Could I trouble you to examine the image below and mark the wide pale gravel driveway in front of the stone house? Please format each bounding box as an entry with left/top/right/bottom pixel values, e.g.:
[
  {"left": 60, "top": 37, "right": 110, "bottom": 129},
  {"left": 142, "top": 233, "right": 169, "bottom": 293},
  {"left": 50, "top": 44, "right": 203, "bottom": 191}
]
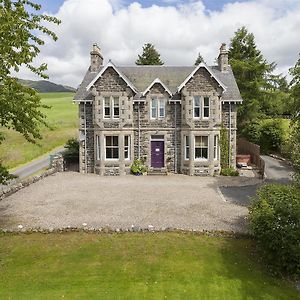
[{"left": 0, "top": 172, "right": 248, "bottom": 232}]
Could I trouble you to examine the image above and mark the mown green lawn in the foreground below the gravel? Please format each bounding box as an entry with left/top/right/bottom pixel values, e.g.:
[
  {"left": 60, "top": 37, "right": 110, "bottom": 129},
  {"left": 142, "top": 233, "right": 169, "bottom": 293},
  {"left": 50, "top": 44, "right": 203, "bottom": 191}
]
[{"left": 0, "top": 233, "right": 300, "bottom": 300}]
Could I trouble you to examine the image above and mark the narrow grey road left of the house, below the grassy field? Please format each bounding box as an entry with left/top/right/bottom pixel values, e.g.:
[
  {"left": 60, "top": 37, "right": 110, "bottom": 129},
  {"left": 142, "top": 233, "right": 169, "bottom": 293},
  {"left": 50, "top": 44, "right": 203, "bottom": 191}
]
[{"left": 12, "top": 147, "right": 64, "bottom": 179}]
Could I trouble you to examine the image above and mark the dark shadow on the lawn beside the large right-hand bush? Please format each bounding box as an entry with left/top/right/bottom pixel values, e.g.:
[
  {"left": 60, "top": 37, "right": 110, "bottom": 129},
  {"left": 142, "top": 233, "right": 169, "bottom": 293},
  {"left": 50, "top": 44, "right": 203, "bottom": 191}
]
[{"left": 216, "top": 238, "right": 300, "bottom": 300}]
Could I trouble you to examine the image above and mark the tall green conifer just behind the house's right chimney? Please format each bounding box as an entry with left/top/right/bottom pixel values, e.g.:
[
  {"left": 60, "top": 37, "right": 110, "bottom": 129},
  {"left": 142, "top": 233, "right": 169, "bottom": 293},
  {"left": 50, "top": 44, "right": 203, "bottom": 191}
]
[{"left": 229, "top": 27, "right": 276, "bottom": 127}]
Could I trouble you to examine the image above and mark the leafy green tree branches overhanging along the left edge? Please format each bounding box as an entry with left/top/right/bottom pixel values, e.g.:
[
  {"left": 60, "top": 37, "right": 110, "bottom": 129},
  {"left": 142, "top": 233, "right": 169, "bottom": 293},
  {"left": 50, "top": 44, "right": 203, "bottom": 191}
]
[{"left": 0, "top": 0, "right": 60, "bottom": 183}]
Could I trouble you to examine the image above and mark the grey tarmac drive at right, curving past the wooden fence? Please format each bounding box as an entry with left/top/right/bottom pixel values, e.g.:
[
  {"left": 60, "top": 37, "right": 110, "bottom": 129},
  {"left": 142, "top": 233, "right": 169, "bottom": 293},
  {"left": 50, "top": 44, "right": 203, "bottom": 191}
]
[{"left": 219, "top": 155, "right": 293, "bottom": 206}]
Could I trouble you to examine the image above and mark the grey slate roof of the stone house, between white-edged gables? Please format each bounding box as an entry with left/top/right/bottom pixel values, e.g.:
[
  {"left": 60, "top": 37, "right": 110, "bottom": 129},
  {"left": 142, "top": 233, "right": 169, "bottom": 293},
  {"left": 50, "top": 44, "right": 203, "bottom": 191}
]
[{"left": 74, "top": 66, "right": 242, "bottom": 101}]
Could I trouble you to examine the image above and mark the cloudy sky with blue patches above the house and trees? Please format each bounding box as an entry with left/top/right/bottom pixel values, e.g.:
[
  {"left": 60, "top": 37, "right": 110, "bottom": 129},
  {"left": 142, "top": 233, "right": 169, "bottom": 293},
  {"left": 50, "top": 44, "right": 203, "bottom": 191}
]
[{"left": 18, "top": 0, "right": 300, "bottom": 87}]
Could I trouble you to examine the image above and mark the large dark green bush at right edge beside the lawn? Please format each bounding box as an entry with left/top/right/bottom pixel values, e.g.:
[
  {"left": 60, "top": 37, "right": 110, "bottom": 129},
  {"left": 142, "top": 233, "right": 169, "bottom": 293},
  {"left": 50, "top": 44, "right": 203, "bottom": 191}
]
[{"left": 250, "top": 184, "right": 300, "bottom": 275}]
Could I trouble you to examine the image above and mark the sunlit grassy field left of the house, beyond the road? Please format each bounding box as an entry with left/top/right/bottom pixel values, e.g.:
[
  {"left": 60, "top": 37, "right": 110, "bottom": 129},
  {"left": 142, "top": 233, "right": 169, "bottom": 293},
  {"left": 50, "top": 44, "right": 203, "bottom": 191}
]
[{"left": 0, "top": 93, "right": 78, "bottom": 168}]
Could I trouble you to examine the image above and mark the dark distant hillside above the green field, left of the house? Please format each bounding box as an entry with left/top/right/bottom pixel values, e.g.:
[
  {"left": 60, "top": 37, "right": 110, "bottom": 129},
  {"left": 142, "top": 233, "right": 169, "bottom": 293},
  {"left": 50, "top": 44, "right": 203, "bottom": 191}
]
[{"left": 19, "top": 79, "right": 75, "bottom": 93}]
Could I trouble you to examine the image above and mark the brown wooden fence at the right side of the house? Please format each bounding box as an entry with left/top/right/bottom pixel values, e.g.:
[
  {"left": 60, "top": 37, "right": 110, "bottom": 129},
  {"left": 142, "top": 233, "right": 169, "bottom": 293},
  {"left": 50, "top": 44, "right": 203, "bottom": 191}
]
[{"left": 237, "top": 138, "right": 265, "bottom": 178}]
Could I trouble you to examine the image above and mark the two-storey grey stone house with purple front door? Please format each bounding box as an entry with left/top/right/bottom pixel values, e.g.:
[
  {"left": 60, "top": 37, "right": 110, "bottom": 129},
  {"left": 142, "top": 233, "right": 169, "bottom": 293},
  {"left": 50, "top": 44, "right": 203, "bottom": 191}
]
[{"left": 74, "top": 44, "right": 242, "bottom": 175}]
